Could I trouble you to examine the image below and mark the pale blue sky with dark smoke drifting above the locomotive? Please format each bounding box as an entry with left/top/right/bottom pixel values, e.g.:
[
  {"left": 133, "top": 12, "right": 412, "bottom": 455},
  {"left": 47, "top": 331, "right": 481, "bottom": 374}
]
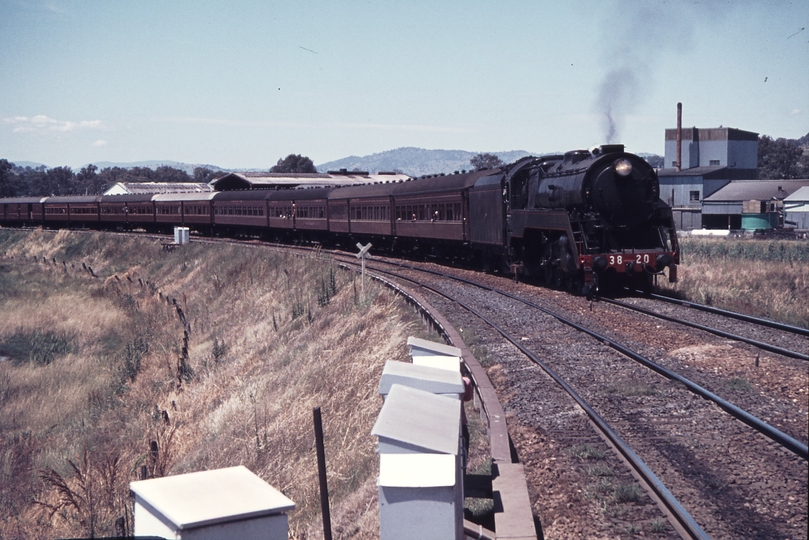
[{"left": 0, "top": 0, "right": 809, "bottom": 169}]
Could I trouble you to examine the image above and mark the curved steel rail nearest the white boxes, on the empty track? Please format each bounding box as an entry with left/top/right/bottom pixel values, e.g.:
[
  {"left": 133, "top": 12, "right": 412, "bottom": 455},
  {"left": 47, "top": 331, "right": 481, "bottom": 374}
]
[{"left": 362, "top": 269, "right": 710, "bottom": 539}]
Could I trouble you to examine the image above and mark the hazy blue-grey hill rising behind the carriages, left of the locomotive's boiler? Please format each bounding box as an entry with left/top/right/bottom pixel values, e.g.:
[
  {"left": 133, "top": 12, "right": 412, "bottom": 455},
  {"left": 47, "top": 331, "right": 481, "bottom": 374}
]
[{"left": 317, "top": 147, "right": 540, "bottom": 176}]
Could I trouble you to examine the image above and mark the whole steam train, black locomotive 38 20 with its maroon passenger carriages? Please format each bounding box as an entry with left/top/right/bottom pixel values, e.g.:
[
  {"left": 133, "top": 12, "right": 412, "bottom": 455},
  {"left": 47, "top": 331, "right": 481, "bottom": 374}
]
[{"left": 0, "top": 145, "right": 679, "bottom": 295}]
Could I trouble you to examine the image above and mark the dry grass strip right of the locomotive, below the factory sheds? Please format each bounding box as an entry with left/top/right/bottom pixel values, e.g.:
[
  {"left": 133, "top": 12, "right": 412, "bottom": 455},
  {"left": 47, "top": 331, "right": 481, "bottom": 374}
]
[{"left": 658, "top": 238, "right": 809, "bottom": 328}]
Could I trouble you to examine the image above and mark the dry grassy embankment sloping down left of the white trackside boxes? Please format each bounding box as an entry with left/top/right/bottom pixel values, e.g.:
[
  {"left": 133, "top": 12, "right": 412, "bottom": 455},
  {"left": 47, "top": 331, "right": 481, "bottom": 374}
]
[{"left": 0, "top": 230, "right": 437, "bottom": 538}]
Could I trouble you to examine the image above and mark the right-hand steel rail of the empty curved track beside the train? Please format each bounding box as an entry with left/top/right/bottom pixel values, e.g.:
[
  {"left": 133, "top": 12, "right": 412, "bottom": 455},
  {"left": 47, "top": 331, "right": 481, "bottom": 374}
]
[{"left": 368, "top": 263, "right": 809, "bottom": 461}]
